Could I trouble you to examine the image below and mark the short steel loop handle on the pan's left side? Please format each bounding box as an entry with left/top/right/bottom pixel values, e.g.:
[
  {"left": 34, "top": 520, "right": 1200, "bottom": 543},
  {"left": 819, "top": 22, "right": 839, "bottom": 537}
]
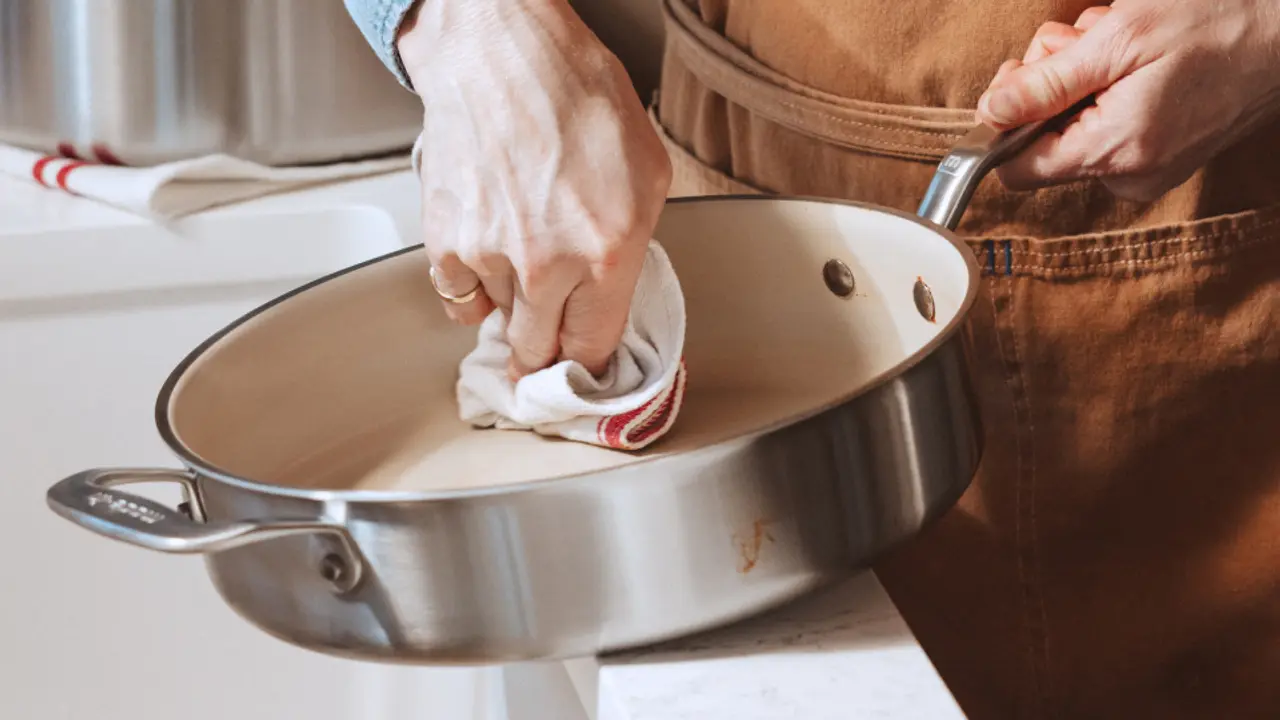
[{"left": 46, "top": 468, "right": 361, "bottom": 589}]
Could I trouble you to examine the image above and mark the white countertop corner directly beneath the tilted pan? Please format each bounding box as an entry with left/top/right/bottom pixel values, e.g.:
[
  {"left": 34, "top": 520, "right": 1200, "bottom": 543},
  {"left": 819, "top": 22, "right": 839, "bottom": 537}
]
[{"left": 568, "top": 573, "right": 964, "bottom": 720}]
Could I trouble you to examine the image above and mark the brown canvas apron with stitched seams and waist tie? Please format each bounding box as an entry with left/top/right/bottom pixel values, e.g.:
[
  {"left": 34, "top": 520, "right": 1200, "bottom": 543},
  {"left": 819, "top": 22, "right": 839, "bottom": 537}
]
[{"left": 654, "top": 0, "right": 1280, "bottom": 720}]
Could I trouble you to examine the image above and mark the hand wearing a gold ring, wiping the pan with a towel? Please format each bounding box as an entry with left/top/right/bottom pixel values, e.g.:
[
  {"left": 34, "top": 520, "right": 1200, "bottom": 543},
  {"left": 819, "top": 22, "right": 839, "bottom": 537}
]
[{"left": 397, "top": 0, "right": 672, "bottom": 378}]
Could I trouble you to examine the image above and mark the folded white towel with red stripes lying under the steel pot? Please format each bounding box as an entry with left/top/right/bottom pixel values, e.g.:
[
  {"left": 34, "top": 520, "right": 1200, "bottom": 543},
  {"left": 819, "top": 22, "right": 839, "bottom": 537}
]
[{"left": 0, "top": 145, "right": 410, "bottom": 219}]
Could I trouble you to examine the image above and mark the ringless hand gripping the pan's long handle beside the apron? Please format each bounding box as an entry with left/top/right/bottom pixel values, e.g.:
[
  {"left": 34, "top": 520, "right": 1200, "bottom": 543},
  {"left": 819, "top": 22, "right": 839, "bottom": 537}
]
[{"left": 978, "top": 0, "right": 1280, "bottom": 200}]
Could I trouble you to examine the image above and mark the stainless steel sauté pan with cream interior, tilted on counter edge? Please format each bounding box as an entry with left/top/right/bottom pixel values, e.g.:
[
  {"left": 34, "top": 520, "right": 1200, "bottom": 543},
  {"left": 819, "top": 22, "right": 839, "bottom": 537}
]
[{"left": 49, "top": 116, "right": 1054, "bottom": 664}]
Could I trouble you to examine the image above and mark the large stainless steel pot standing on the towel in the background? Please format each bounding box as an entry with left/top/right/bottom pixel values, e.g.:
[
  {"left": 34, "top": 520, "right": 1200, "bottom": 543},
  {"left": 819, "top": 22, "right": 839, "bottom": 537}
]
[{"left": 0, "top": 0, "right": 422, "bottom": 165}]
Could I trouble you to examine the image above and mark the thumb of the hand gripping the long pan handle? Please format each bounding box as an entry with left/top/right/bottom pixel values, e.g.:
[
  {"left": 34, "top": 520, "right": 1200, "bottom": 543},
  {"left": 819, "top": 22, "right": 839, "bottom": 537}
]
[{"left": 978, "top": 33, "right": 1114, "bottom": 129}]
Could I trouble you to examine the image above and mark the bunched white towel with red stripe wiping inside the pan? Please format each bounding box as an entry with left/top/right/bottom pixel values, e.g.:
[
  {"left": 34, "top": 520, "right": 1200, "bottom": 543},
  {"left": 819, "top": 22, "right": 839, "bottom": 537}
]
[{"left": 457, "top": 241, "right": 685, "bottom": 450}]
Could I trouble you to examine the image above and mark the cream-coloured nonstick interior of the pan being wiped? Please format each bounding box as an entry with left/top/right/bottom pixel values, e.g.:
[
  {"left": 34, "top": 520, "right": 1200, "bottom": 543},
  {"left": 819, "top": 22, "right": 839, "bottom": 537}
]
[{"left": 166, "top": 197, "right": 974, "bottom": 492}]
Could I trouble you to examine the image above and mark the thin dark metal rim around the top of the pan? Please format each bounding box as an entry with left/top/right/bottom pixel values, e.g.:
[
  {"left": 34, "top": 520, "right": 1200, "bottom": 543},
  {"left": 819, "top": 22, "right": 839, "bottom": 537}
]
[{"left": 155, "top": 193, "right": 980, "bottom": 503}]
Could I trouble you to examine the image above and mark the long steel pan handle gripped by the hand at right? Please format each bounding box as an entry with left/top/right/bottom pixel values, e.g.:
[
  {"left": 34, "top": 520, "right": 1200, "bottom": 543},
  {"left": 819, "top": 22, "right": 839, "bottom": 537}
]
[{"left": 916, "top": 97, "right": 1093, "bottom": 231}]
